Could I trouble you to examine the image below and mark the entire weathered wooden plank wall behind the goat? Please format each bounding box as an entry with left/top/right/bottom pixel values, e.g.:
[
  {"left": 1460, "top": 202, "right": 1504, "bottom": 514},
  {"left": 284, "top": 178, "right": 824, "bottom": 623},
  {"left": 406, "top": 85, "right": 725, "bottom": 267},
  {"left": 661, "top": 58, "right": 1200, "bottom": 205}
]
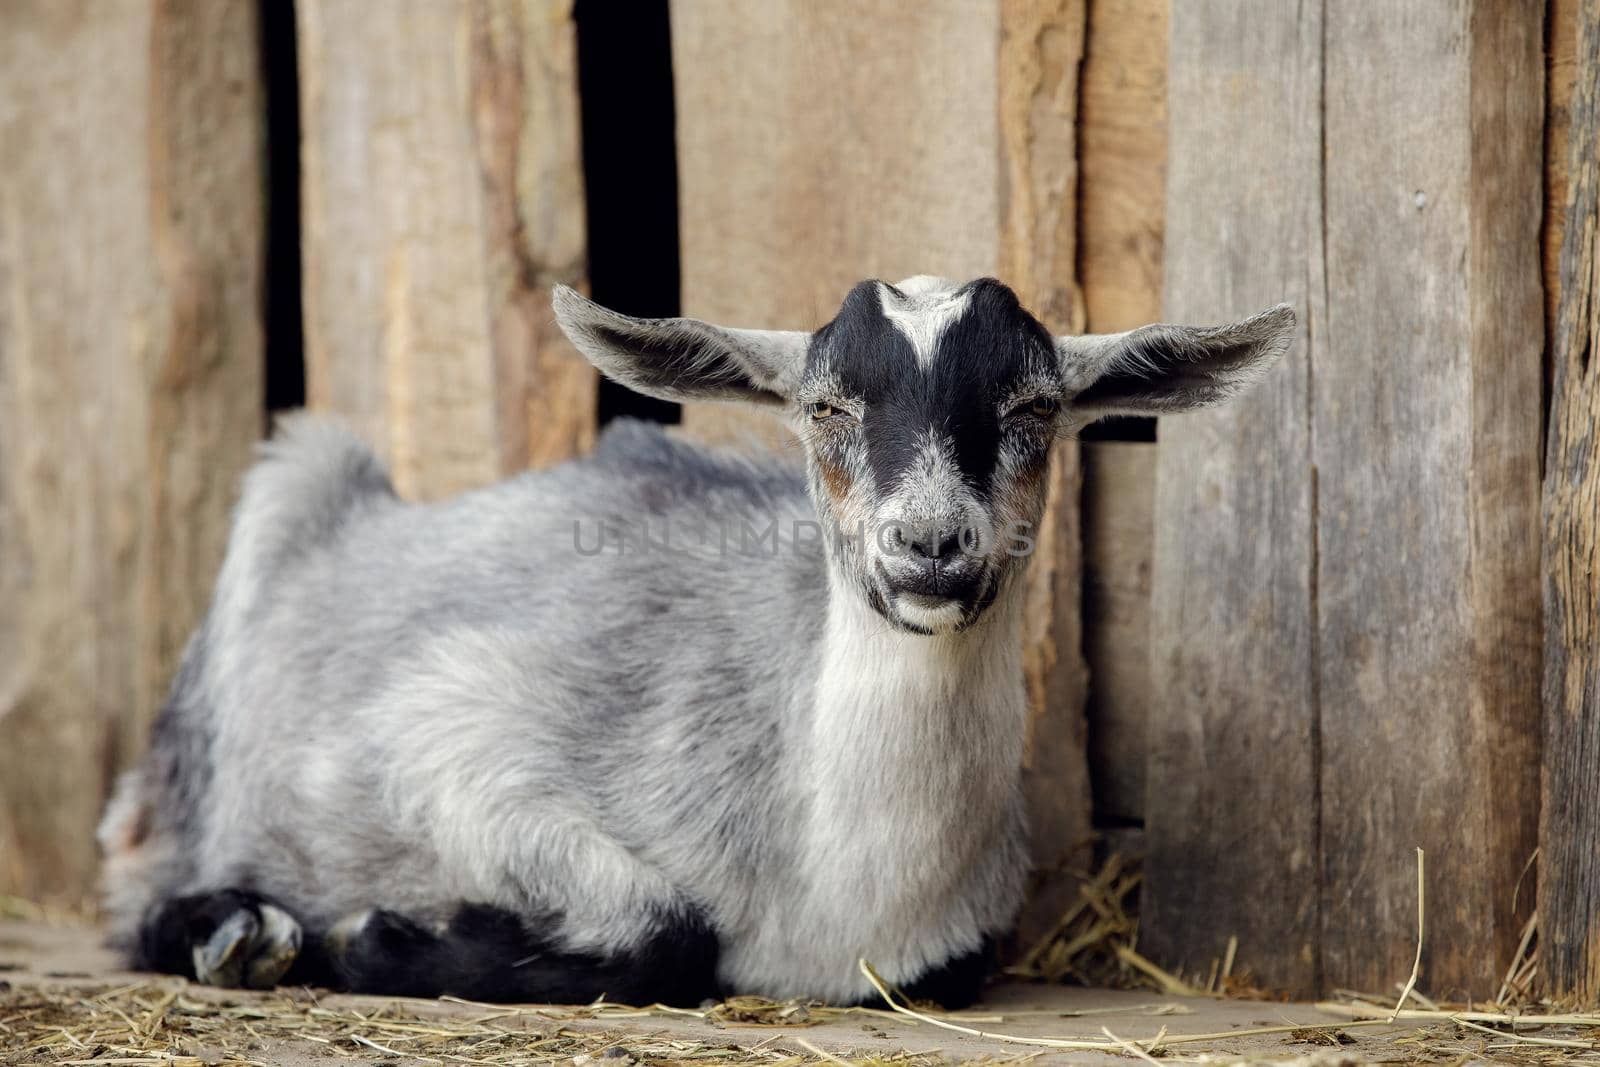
[{"left": 0, "top": 0, "right": 1580, "bottom": 1000}]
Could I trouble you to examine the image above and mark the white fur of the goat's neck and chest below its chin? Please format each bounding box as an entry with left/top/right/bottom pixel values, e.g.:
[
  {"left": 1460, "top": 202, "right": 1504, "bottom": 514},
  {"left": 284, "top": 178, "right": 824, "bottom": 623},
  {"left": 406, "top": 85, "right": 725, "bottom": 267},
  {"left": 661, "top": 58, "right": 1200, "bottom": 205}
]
[{"left": 725, "top": 597, "right": 1026, "bottom": 998}]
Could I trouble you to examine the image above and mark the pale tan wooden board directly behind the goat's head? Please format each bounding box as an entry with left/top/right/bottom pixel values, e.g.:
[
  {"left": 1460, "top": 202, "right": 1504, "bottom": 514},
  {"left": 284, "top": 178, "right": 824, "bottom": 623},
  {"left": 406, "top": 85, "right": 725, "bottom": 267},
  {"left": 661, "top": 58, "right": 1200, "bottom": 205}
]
[{"left": 672, "top": 0, "right": 1090, "bottom": 937}]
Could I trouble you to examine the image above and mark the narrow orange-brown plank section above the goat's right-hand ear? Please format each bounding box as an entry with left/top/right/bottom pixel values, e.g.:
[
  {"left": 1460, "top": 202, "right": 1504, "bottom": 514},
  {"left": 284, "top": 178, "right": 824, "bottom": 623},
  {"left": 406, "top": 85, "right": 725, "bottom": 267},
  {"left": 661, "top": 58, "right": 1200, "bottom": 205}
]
[{"left": 1078, "top": 0, "right": 1171, "bottom": 333}]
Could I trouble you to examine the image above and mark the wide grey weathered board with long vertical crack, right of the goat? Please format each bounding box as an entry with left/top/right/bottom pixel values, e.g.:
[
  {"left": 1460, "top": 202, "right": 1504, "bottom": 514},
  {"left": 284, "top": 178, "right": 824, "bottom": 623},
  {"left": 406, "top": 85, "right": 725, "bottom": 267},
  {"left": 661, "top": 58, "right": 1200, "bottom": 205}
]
[{"left": 1142, "top": 0, "right": 1544, "bottom": 997}]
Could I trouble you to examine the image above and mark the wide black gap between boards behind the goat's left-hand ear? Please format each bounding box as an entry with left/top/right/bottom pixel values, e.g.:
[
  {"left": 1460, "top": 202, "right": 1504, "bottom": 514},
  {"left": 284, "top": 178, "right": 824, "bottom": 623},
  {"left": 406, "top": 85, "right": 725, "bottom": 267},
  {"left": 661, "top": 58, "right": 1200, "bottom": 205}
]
[{"left": 573, "top": 0, "right": 680, "bottom": 426}]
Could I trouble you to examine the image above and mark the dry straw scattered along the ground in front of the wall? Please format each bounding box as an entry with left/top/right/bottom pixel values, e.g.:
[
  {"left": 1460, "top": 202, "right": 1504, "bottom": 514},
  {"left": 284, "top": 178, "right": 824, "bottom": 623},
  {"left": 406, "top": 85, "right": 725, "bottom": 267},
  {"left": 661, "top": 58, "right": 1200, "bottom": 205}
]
[{"left": 0, "top": 854, "right": 1600, "bottom": 1067}]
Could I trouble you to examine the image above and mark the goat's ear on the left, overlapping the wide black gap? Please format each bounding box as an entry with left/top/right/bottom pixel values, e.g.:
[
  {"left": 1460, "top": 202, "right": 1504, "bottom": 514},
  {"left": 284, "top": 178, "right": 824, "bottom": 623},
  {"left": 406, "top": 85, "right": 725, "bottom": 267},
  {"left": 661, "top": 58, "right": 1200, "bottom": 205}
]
[{"left": 550, "top": 285, "right": 811, "bottom": 403}]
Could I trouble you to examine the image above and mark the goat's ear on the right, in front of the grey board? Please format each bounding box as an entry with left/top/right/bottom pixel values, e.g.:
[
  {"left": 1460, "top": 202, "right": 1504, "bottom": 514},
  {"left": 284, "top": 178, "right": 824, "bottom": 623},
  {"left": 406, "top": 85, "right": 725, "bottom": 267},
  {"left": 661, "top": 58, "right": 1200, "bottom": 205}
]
[{"left": 1056, "top": 304, "right": 1294, "bottom": 422}]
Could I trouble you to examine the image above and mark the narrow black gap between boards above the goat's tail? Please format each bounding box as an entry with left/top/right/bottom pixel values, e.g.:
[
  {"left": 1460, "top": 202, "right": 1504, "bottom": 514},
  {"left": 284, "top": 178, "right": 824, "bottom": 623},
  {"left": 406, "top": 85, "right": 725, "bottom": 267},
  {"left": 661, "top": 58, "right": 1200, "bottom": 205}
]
[{"left": 256, "top": 0, "right": 306, "bottom": 413}]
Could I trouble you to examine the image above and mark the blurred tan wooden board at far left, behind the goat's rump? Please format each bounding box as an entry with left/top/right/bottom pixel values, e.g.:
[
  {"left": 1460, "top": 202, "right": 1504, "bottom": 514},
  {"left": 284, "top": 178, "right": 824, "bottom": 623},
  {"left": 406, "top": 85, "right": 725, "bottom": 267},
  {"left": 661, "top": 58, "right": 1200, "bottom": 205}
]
[{"left": 0, "top": 0, "right": 262, "bottom": 902}]
